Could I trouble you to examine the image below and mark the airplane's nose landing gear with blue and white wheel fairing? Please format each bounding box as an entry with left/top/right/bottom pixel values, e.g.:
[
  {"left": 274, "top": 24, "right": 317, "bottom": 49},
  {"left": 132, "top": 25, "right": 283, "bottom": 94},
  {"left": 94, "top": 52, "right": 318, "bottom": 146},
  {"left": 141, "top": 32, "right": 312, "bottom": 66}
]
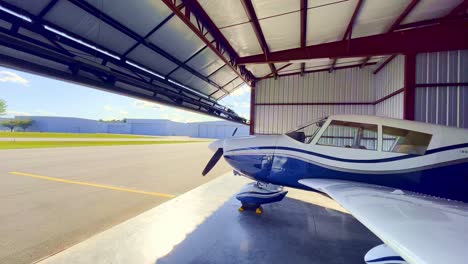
[{"left": 236, "top": 182, "right": 288, "bottom": 215}]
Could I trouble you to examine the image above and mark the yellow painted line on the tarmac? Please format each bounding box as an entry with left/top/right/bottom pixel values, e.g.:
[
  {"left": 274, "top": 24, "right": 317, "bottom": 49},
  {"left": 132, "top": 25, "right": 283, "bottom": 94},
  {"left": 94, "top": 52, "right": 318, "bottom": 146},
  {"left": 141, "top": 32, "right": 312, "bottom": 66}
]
[{"left": 10, "top": 171, "right": 175, "bottom": 198}]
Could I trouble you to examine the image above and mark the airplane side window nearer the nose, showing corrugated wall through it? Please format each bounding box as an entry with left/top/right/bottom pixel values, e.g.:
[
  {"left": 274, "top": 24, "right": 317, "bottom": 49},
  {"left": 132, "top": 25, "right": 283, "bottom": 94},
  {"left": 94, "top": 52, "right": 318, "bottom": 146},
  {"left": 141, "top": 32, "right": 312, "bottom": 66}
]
[{"left": 317, "top": 120, "right": 377, "bottom": 150}]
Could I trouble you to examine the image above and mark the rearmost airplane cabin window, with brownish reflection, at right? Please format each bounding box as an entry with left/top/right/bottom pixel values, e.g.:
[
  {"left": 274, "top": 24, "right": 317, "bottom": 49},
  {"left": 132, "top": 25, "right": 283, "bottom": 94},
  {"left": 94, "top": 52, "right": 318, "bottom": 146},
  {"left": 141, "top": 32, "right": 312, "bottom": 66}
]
[{"left": 382, "top": 126, "right": 432, "bottom": 155}]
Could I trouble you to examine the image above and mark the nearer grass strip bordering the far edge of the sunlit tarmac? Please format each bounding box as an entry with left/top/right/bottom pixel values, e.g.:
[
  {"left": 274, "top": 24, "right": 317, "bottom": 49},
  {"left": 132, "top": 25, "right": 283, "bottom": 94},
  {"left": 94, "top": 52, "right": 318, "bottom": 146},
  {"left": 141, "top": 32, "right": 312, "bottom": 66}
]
[{"left": 0, "top": 140, "right": 200, "bottom": 149}]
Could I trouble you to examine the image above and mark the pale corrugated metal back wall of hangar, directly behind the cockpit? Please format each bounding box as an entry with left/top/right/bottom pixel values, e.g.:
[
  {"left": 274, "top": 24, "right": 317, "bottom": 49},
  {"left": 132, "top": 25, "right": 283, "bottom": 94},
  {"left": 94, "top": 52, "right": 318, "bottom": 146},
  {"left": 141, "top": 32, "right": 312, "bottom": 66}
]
[{"left": 255, "top": 68, "right": 375, "bottom": 134}]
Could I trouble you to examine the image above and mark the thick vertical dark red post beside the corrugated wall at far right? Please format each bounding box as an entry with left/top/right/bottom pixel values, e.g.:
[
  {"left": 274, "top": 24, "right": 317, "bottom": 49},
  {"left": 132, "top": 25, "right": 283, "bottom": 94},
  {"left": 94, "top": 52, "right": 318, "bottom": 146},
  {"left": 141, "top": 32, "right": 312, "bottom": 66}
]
[{"left": 403, "top": 53, "right": 416, "bottom": 120}]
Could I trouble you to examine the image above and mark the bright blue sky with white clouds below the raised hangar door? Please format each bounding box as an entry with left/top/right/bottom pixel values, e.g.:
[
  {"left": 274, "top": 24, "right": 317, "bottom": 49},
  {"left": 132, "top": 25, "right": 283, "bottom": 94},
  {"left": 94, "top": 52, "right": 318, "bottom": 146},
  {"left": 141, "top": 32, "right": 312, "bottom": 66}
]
[{"left": 0, "top": 67, "right": 250, "bottom": 122}]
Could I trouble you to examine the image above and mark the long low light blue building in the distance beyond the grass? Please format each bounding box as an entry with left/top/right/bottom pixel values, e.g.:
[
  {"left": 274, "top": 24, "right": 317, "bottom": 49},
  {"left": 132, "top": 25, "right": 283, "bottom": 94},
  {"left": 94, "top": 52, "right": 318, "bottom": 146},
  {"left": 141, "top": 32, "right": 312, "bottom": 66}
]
[{"left": 0, "top": 116, "right": 249, "bottom": 138}]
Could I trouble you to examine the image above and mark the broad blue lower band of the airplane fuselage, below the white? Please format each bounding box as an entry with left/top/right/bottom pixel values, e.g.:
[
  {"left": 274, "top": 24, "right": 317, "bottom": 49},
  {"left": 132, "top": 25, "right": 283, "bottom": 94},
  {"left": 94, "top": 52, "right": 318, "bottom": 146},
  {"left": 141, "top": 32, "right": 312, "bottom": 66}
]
[{"left": 225, "top": 154, "right": 468, "bottom": 202}]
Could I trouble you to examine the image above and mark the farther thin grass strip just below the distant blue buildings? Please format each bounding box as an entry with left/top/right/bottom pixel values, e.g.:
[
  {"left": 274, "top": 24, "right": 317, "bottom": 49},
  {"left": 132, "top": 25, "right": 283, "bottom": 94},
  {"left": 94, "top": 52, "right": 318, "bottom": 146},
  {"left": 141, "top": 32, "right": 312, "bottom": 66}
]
[{"left": 0, "top": 132, "right": 155, "bottom": 138}]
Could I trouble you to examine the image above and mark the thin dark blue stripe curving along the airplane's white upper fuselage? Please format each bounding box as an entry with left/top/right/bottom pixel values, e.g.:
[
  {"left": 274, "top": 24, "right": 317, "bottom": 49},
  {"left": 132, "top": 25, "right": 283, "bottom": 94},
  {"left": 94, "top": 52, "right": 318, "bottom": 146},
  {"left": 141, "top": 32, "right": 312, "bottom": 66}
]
[{"left": 226, "top": 143, "right": 468, "bottom": 163}]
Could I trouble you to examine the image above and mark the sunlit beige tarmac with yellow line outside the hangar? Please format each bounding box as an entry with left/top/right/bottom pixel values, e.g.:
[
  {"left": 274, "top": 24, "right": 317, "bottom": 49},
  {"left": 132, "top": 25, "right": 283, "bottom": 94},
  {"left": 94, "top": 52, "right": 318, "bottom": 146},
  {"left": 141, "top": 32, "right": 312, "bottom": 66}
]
[{"left": 0, "top": 142, "right": 230, "bottom": 263}]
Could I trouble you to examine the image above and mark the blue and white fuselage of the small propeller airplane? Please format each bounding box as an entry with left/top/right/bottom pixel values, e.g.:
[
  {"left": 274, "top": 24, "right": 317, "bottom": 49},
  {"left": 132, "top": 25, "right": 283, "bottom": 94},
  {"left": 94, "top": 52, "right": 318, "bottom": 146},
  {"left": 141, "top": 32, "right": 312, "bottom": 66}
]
[{"left": 218, "top": 115, "right": 468, "bottom": 202}]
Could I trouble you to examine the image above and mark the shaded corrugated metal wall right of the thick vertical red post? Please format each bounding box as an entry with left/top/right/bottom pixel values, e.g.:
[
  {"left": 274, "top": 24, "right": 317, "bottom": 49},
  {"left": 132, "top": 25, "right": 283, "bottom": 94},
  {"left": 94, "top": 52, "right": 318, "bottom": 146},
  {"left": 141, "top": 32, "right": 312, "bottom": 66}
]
[{"left": 415, "top": 50, "right": 468, "bottom": 128}]
